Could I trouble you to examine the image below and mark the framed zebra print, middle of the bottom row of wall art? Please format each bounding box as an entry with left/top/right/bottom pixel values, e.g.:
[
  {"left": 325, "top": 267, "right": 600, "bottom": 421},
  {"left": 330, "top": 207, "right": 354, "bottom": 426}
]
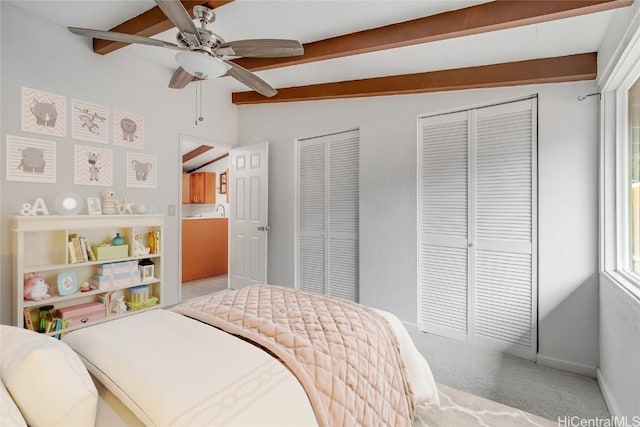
[{"left": 73, "top": 145, "right": 113, "bottom": 187}]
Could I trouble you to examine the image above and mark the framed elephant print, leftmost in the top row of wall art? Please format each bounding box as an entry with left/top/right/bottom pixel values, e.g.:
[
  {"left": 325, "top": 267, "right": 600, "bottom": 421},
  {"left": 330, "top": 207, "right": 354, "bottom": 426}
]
[{"left": 20, "top": 87, "right": 67, "bottom": 137}]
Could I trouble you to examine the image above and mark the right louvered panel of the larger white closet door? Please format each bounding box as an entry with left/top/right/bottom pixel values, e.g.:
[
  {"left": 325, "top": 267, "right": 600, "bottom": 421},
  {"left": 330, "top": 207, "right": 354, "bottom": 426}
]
[{"left": 471, "top": 99, "right": 537, "bottom": 358}]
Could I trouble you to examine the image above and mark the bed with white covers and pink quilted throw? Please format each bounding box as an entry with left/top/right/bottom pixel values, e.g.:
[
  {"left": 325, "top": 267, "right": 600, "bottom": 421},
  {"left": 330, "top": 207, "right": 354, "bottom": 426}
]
[{"left": 3, "top": 285, "right": 438, "bottom": 426}]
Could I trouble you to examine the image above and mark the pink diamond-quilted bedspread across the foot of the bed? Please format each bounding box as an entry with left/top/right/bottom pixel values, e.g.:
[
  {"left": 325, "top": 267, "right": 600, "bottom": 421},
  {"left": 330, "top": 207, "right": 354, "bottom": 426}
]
[{"left": 173, "top": 285, "right": 415, "bottom": 426}]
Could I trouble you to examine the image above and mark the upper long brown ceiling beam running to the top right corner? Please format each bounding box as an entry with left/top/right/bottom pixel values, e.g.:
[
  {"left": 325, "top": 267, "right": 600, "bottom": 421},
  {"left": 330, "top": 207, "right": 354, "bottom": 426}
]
[{"left": 234, "top": 0, "right": 633, "bottom": 71}]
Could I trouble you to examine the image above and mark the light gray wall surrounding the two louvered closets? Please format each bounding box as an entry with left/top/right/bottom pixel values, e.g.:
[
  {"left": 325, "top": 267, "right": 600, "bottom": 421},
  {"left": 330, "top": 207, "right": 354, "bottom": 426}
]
[{"left": 238, "top": 82, "right": 598, "bottom": 372}]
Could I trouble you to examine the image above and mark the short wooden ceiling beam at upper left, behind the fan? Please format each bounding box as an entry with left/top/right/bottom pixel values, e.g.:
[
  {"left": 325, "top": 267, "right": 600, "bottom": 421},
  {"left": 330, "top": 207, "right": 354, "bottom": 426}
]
[{"left": 93, "top": 0, "right": 233, "bottom": 55}]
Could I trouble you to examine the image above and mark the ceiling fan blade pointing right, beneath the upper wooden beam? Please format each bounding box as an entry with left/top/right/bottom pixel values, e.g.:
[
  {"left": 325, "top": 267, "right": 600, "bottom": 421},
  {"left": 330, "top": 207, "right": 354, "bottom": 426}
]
[{"left": 216, "top": 39, "right": 304, "bottom": 58}]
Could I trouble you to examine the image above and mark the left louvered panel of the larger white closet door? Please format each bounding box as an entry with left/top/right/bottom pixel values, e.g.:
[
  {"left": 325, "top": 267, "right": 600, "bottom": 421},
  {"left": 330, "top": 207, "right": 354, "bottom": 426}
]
[{"left": 418, "top": 112, "right": 469, "bottom": 339}]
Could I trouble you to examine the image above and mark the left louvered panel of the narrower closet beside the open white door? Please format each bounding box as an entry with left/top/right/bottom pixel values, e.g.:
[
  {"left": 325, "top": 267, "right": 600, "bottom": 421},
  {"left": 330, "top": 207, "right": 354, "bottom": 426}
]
[{"left": 296, "top": 137, "right": 327, "bottom": 295}]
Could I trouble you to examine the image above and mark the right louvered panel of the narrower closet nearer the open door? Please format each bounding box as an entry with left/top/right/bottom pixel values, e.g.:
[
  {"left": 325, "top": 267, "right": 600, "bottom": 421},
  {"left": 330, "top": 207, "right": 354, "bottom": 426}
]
[{"left": 328, "top": 131, "right": 360, "bottom": 302}]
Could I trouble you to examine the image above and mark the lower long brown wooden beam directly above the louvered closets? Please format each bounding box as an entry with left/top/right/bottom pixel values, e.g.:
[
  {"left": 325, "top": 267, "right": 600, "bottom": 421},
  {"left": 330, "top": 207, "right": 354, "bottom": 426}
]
[{"left": 231, "top": 53, "right": 598, "bottom": 105}]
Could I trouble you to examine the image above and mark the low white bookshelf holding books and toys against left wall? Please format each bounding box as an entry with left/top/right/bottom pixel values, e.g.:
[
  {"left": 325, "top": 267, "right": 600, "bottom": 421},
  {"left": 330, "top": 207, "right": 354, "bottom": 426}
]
[{"left": 9, "top": 215, "right": 165, "bottom": 335}]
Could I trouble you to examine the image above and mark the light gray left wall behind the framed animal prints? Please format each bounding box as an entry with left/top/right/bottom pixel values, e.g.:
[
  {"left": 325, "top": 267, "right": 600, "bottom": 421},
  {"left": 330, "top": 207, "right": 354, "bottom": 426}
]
[{"left": 0, "top": 2, "right": 237, "bottom": 323}]
